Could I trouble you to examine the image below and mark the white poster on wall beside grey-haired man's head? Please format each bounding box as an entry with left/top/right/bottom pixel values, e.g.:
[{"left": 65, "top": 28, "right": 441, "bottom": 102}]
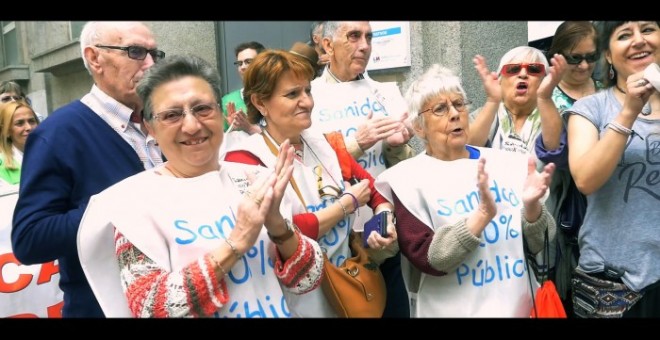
[{"left": 367, "top": 21, "right": 410, "bottom": 70}]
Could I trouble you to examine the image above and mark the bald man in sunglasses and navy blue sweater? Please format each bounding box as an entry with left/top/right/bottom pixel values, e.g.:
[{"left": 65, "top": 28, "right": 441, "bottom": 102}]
[{"left": 11, "top": 21, "right": 165, "bottom": 317}]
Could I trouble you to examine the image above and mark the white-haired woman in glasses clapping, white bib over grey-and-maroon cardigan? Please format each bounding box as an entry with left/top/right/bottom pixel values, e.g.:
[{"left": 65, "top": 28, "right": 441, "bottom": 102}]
[{"left": 376, "top": 65, "right": 555, "bottom": 317}]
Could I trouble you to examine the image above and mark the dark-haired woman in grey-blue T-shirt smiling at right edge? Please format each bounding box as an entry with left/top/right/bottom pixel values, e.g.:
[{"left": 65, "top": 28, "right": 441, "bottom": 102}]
[{"left": 567, "top": 21, "right": 660, "bottom": 318}]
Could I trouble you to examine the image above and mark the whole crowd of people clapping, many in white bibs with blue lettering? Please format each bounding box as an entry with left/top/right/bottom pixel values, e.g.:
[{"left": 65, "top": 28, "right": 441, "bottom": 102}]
[{"left": 0, "top": 21, "right": 660, "bottom": 318}]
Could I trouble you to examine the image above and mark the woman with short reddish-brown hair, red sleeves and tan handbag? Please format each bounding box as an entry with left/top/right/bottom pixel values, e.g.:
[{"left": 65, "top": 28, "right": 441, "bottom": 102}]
[{"left": 225, "top": 50, "right": 398, "bottom": 317}]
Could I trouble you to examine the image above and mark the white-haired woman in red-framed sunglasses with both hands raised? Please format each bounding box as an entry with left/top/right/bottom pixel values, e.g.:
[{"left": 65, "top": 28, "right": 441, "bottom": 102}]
[{"left": 468, "top": 46, "right": 566, "bottom": 162}]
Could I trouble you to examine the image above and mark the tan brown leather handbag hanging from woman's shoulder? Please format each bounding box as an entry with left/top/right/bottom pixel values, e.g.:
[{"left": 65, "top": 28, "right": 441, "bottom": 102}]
[{"left": 321, "top": 232, "right": 387, "bottom": 318}]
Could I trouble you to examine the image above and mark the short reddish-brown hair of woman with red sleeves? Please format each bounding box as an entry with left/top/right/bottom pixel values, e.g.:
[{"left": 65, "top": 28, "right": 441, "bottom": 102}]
[{"left": 243, "top": 49, "right": 314, "bottom": 124}]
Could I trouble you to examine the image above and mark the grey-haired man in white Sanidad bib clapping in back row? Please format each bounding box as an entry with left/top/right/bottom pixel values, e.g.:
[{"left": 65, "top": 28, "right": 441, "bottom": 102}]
[{"left": 312, "top": 21, "right": 414, "bottom": 317}]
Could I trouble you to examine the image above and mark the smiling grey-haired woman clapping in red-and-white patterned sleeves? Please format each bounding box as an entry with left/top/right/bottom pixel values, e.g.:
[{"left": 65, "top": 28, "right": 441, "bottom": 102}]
[{"left": 78, "top": 56, "right": 323, "bottom": 317}]
